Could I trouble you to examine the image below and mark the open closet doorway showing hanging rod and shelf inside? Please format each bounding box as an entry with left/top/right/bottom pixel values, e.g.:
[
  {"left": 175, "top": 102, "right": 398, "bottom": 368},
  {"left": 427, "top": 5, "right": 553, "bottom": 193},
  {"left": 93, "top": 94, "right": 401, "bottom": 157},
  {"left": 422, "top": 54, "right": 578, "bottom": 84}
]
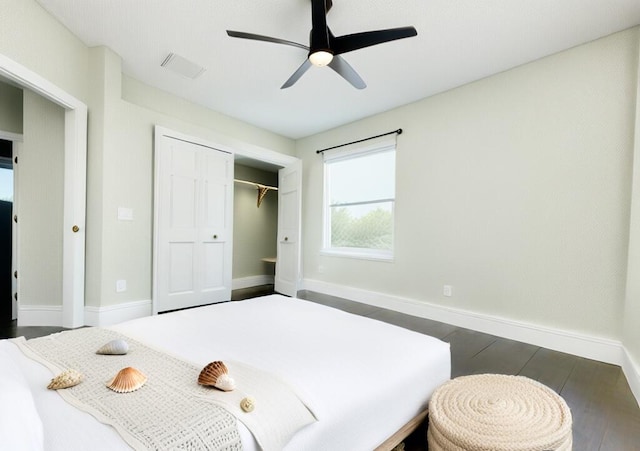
[{"left": 231, "top": 155, "right": 281, "bottom": 300}]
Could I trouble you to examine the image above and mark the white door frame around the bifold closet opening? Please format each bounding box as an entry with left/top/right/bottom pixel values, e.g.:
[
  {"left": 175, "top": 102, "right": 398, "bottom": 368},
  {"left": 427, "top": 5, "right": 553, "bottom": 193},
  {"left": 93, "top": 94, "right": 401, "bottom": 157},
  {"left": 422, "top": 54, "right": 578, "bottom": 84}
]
[{"left": 151, "top": 125, "right": 302, "bottom": 315}]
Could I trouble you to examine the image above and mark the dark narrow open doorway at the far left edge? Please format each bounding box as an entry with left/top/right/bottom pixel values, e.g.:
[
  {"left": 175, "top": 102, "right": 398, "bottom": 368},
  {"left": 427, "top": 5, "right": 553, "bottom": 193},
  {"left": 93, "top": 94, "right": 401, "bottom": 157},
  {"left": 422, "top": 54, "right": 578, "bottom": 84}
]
[{"left": 0, "top": 139, "right": 15, "bottom": 324}]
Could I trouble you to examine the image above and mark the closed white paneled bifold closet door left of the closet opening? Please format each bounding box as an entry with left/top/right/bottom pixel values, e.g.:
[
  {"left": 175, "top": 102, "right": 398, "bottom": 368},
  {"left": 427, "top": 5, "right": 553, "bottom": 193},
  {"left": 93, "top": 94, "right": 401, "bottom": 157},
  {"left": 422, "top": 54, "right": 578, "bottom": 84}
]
[{"left": 154, "top": 136, "right": 234, "bottom": 312}]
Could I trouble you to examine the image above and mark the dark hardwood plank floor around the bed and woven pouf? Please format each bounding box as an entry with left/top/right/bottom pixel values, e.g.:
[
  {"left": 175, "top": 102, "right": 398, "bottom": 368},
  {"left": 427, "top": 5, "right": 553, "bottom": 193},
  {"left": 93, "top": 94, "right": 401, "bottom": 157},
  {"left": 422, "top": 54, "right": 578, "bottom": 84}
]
[{"left": 0, "top": 285, "right": 640, "bottom": 451}]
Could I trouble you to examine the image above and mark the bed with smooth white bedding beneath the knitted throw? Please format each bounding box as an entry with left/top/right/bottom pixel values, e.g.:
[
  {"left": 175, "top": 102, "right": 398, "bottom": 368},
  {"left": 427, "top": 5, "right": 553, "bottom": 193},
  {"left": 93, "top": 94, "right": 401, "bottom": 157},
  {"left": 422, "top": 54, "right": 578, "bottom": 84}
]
[{"left": 0, "top": 295, "right": 451, "bottom": 451}]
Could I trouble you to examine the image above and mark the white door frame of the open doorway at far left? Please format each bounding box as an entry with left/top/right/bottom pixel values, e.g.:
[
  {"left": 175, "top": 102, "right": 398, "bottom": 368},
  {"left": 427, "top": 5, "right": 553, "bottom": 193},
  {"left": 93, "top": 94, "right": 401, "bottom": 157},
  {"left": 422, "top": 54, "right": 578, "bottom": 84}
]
[{"left": 0, "top": 54, "right": 87, "bottom": 328}]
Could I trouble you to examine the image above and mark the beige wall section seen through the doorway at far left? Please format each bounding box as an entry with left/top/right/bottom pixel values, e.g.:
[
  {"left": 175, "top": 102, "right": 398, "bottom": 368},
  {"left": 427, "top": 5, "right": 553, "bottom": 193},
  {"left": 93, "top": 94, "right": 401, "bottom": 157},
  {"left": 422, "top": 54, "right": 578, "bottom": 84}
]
[{"left": 17, "top": 91, "right": 64, "bottom": 307}]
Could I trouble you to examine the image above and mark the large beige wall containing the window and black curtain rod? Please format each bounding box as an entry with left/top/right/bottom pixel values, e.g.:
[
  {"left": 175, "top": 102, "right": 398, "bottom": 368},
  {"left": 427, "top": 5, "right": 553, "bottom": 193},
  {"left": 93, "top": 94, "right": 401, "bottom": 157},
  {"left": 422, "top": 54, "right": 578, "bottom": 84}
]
[{"left": 297, "top": 28, "right": 640, "bottom": 339}]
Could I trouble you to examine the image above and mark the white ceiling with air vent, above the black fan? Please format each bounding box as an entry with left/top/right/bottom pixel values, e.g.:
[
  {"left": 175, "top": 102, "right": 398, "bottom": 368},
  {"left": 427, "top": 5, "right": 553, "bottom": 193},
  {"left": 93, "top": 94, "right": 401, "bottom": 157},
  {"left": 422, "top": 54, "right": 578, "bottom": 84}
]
[{"left": 33, "top": 0, "right": 640, "bottom": 139}]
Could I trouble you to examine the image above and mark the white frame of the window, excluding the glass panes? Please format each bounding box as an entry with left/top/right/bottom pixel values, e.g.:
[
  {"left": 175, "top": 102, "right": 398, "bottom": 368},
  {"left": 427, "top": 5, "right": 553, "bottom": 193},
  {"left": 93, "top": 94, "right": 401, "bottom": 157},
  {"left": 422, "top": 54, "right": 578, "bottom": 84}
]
[{"left": 320, "top": 139, "right": 397, "bottom": 262}]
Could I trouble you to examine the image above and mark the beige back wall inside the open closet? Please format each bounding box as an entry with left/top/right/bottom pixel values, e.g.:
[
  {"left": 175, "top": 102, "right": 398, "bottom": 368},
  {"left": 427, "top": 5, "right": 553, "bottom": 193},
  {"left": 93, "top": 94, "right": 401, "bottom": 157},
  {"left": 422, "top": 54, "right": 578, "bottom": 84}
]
[{"left": 233, "top": 164, "right": 278, "bottom": 279}]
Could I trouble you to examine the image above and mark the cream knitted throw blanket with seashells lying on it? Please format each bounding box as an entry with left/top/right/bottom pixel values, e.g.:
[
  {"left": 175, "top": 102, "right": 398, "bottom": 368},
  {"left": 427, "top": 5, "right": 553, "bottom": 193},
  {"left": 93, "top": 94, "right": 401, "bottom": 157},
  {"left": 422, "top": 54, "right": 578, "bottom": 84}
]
[{"left": 14, "top": 328, "right": 315, "bottom": 451}]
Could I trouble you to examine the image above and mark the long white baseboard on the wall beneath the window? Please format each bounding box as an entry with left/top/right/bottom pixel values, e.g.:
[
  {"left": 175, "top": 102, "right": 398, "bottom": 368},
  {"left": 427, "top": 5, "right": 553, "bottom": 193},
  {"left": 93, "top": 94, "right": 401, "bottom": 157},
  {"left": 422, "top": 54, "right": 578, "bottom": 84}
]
[{"left": 304, "top": 279, "right": 626, "bottom": 366}]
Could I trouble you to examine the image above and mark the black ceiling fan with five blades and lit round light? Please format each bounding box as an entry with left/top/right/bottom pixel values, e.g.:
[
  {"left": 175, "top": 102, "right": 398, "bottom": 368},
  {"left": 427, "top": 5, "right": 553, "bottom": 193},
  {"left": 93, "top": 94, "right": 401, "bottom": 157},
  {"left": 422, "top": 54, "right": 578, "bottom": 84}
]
[{"left": 227, "top": 0, "right": 418, "bottom": 89}]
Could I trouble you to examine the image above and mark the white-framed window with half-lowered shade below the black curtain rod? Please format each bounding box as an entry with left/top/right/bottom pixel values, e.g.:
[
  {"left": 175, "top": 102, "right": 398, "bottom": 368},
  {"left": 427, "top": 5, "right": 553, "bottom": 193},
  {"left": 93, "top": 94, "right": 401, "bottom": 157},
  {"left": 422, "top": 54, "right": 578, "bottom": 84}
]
[{"left": 323, "top": 141, "right": 396, "bottom": 260}]
